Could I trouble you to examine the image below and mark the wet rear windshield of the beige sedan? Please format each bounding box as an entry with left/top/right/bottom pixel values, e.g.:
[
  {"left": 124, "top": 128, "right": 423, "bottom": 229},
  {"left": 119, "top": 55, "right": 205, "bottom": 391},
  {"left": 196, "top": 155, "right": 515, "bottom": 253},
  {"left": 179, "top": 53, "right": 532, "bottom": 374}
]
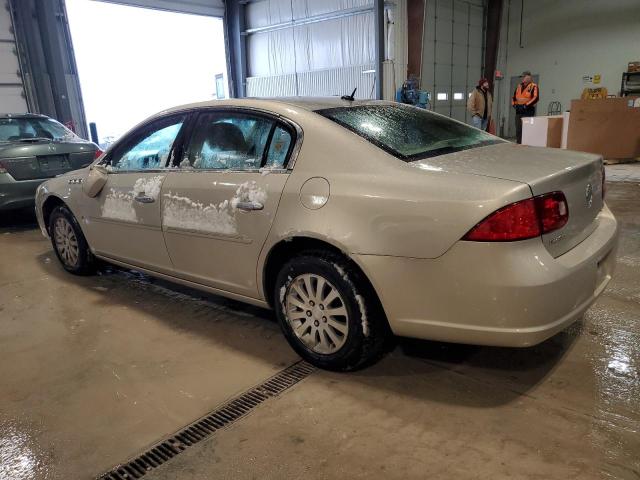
[{"left": 316, "top": 104, "right": 504, "bottom": 162}]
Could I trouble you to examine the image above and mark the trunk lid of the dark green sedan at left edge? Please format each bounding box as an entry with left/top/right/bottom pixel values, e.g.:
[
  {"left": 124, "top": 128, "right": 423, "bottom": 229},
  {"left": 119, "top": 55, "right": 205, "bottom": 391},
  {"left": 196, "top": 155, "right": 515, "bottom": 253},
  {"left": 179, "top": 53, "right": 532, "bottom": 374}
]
[{"left": 0, "top": 140, "right": 96, "bottom": 180}]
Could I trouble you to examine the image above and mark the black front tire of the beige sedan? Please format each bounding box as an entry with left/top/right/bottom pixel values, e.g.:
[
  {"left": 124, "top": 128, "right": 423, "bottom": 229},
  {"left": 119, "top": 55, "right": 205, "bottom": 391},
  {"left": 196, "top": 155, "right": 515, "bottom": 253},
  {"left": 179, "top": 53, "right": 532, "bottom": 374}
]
[{"left": 49, "top": 205, "right": 96, "bottom": 275}]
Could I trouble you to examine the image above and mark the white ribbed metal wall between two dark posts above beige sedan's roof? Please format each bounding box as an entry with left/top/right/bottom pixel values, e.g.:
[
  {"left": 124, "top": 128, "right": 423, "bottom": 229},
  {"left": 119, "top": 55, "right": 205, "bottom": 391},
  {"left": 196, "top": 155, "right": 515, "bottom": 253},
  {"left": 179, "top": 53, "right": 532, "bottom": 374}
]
[{"left": 246, "top": 0, "right": 375, "bottom": 98}]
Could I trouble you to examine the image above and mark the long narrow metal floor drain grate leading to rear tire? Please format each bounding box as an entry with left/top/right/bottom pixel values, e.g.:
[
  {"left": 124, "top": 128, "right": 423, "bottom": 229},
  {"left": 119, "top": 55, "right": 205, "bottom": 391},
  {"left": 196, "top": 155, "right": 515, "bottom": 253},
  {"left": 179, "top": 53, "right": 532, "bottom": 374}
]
[{"left": 98, "top": 361, "right": 315, "bottom": 480}]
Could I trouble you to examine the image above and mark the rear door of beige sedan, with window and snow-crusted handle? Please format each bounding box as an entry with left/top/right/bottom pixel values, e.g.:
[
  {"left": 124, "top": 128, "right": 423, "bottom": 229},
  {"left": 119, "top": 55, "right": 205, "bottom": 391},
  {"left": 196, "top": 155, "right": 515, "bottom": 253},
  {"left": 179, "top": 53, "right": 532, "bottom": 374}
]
[{"left": 162, "top": 109, "right": 296, "bottom": 298}]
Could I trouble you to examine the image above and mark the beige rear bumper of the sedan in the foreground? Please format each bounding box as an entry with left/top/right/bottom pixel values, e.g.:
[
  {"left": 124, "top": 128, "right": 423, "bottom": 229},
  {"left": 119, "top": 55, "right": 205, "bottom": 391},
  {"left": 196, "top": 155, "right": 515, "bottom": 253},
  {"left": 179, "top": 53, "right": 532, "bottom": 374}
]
[{"left": 355, "top": 206, "right": 618, "bottom": 347}]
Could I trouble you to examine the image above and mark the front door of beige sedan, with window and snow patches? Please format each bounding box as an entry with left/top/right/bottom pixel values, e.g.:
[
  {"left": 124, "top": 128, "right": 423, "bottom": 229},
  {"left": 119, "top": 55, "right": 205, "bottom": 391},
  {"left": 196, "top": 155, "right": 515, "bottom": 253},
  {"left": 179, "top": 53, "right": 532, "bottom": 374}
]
[{"left": 83, "top": 114, "right": 187, "bottom": 273}]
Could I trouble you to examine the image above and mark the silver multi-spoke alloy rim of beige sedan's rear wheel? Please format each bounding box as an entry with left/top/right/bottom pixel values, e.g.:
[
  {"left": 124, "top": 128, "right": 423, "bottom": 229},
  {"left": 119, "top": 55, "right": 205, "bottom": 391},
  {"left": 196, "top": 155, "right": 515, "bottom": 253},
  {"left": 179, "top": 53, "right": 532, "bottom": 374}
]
[{"left": 285, "top": 273, "right": 349, "bottom": 355}]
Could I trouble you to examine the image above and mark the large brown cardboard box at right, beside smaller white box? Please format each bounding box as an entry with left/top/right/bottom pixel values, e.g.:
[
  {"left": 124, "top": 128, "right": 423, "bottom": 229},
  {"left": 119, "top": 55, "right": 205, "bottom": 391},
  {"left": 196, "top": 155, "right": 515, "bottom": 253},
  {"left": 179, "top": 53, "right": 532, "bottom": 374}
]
[{"left": 567, "top": 97, "right": 640, "bottom": 158}]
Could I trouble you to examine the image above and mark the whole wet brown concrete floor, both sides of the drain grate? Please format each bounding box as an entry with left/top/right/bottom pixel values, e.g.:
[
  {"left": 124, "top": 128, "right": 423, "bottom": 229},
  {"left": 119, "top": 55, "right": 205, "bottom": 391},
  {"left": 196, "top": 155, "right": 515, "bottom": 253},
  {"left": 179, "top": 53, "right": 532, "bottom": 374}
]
[{"left": 0, "top": 174, "right": 640, "bottom": 480}]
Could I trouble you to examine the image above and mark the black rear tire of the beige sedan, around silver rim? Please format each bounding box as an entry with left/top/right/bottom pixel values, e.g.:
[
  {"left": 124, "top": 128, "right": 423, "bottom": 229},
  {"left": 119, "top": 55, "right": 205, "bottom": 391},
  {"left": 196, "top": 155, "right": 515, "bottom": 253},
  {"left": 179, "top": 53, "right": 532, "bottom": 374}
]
[{"left": 273, "top": 250, "right": 392, "bottom": 371}]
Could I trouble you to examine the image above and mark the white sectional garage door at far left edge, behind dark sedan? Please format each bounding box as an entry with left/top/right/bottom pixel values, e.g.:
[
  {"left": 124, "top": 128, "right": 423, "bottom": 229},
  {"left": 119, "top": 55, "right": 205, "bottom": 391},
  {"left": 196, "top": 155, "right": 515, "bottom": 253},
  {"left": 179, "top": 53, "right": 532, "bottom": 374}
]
[{"left": 0, "top": 0, "right": 28, "bottom": 113}]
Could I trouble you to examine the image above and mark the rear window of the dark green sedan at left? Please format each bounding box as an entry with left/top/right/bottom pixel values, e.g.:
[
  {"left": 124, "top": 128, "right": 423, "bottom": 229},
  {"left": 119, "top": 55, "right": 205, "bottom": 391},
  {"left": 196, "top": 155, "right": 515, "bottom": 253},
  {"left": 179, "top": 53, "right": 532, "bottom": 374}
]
[{"left": 0, "top": 117, "right": 77, "bottom": 142}]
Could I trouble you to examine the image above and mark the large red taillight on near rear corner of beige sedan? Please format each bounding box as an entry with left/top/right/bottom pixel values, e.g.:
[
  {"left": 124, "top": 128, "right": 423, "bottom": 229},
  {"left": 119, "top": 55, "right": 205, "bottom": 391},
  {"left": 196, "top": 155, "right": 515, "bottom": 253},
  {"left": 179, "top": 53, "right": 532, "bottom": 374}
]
[{"left": 462, "top": 192, "right": 569, "bottom": 242}]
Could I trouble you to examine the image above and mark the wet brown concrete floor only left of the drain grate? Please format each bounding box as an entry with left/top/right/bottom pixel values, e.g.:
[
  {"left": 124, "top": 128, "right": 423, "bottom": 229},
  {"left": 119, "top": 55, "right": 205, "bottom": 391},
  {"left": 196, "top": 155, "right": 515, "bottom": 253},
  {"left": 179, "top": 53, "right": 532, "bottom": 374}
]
[{"left": 0, "top": 217, "right": 298, "bottom": 480}]
